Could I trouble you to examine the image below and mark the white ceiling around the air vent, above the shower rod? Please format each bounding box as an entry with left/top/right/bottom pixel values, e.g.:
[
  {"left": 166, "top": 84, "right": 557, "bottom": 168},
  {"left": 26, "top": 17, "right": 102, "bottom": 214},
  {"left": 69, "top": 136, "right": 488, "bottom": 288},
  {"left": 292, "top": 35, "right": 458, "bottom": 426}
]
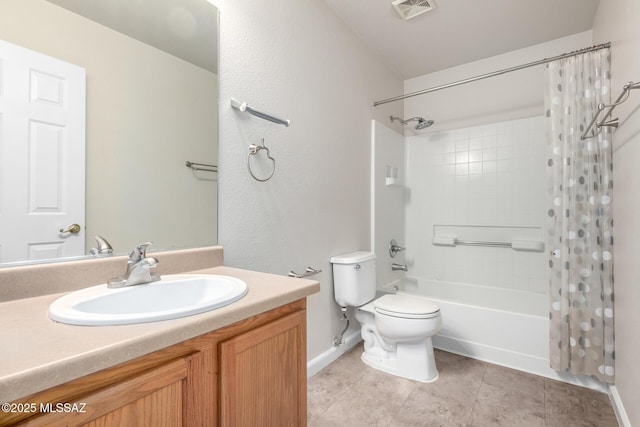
[{"left": 324, "top": 0, "right": 599, "bottom": 79}]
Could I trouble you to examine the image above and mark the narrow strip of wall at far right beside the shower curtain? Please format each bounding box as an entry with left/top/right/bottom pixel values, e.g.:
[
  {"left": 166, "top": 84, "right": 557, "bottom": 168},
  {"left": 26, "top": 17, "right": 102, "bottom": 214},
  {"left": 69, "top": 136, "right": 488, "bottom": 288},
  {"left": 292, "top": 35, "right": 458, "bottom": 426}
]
[{"left": 593, "top": 0, "right": 640, "bottom": 426}]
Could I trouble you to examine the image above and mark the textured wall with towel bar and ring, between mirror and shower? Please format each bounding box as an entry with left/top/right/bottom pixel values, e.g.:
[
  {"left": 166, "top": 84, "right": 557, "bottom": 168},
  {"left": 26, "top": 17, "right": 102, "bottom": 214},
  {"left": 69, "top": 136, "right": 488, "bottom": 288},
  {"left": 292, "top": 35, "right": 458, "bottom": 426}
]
[{"left": 209, "top": 0, "right": 402, "bottom": 366}]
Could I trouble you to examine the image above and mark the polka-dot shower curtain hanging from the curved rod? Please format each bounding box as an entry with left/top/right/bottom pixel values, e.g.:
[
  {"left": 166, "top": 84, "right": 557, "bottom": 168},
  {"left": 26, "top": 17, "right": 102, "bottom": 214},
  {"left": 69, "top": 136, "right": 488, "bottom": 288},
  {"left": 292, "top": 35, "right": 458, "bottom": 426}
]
[{"left": 545, "top": 49, "right": 614, "bottom": 383}]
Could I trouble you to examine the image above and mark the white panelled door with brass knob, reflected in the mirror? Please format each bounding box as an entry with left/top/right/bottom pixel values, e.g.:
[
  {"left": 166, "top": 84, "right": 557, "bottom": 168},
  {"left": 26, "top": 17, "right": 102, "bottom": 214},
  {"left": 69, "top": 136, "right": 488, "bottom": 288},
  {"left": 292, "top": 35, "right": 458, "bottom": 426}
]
[{"left": 0, "top": 41, "right": 86, "bottom": 263}]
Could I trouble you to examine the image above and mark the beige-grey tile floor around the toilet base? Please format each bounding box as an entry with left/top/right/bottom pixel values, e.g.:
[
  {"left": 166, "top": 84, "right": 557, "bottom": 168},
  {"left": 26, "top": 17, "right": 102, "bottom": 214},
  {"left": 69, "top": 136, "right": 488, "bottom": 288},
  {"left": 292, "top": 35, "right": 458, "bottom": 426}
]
[{"left": 307, "top": 344, "right": 618, "bottom": 427}]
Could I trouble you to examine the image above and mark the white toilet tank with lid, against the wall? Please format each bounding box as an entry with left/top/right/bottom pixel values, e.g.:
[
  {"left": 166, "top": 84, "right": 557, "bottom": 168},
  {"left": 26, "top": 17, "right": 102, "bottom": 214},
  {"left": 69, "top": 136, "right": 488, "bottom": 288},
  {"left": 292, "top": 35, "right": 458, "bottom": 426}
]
[{"left": 331, "top": 251, "right": 376, "bottom": 307}]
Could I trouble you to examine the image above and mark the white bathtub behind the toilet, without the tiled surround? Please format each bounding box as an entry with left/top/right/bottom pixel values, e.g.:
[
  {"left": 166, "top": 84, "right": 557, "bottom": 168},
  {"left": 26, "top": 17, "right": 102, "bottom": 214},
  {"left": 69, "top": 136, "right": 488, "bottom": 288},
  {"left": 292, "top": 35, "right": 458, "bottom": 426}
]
[{"left": 381, "top": 278, "right": 606, "bottom": 391}]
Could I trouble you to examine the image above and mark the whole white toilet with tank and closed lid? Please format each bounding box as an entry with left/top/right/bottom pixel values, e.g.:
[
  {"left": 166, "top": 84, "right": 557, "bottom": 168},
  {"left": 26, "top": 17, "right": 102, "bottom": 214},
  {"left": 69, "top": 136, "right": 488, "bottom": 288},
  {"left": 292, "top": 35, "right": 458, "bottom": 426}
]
[{"left": 331, "top": 252, "right": 442, "bottom": 382}]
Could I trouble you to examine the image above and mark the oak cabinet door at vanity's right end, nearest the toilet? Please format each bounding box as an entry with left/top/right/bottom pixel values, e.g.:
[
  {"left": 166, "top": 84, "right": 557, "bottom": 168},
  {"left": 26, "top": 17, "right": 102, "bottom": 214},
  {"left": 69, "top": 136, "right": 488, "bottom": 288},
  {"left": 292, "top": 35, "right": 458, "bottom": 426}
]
[{"left": 220, "top": 311, "right": 307, "bottom": 427}]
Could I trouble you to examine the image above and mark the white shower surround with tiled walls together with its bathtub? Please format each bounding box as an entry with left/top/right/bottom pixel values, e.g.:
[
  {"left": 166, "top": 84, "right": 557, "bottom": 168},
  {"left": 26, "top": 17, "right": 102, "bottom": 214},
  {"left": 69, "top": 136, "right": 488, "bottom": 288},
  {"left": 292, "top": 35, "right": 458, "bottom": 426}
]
[{"left": 372, "top": 116, "right": 604, "bottom": 390}]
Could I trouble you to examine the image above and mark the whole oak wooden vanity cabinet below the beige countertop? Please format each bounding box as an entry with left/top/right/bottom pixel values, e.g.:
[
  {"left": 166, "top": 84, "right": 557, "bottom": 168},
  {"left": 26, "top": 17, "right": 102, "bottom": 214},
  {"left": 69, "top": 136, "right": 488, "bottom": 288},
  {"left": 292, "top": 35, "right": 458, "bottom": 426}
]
[{"left": 0, "top": 299, "right": 307, "bottom": 427}]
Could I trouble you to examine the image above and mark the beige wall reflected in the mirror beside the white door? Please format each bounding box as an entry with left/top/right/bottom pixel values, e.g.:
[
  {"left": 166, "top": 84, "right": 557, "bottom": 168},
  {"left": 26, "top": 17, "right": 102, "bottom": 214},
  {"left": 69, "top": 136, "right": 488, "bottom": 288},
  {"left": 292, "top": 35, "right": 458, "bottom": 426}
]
[{"left": 0, "top": 0, "right": 218, "bottom": 253}]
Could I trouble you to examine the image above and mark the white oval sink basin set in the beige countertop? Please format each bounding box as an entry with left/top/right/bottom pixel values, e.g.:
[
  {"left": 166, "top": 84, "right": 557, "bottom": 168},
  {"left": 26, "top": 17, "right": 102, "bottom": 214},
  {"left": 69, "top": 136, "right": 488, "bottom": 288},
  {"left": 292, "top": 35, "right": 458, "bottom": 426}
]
[{"left": 49, "top": 274, "right": 247, "bottom": 326}]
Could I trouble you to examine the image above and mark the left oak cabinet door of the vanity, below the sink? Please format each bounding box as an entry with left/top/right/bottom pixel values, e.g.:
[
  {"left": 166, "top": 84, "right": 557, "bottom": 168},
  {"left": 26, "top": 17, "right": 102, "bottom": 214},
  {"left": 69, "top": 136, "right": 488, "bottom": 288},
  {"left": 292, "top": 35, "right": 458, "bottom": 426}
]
[{"left": 22, "top": 356, "right": 198, "bottom": 427}]
